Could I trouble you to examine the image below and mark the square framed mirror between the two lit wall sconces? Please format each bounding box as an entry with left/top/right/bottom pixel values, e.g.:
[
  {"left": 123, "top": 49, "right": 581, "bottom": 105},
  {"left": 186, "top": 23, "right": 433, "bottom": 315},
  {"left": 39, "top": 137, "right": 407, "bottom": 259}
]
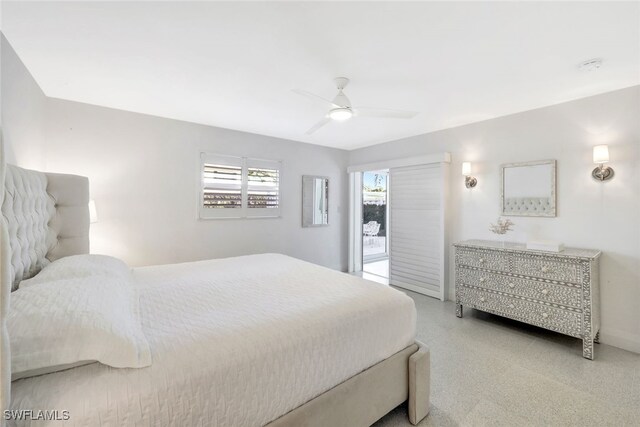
[{"left": 500, "top": 160, "right": 556, "bottom": 217}]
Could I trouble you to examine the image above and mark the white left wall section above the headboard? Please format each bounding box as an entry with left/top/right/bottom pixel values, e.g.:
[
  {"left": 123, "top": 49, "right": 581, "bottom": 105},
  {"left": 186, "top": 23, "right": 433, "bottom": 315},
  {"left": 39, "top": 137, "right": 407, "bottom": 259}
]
[{"left": 0, "top": 34, "right": 47, "bottom": 169}]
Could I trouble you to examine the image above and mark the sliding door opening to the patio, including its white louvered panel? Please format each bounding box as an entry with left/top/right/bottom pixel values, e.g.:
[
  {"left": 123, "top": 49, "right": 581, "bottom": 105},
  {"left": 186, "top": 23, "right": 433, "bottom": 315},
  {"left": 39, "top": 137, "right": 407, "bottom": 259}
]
[{"left": 347, "top": 153, "right": 451, "bottom": 300}]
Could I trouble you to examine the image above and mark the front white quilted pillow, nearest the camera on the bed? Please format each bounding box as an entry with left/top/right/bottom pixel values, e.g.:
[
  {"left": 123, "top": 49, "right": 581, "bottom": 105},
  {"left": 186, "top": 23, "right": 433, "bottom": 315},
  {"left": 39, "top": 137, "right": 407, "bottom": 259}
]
[{"left": 7, "top": 263, "right": 151, "bottom": 380}]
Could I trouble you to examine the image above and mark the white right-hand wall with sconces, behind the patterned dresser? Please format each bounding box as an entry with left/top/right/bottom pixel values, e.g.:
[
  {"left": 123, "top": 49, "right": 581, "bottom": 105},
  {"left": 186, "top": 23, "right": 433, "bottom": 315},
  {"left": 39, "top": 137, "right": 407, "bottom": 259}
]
[{"left": 350, "top": 86, "right": 640, "bottom": 352}]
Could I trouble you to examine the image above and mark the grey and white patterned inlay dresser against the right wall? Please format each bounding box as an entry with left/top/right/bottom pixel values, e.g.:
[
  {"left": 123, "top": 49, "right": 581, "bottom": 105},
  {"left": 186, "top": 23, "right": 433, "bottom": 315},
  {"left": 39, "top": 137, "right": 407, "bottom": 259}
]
[{"left": 453, "top": 240, "right": 600, "bottom": 359}]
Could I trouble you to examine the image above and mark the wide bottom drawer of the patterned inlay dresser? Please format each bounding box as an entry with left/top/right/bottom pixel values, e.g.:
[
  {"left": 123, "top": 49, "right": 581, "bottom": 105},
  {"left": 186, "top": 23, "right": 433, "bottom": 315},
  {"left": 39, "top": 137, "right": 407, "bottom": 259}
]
[{"left": 459, "top": 286, "right": 582, "bottom": 337}]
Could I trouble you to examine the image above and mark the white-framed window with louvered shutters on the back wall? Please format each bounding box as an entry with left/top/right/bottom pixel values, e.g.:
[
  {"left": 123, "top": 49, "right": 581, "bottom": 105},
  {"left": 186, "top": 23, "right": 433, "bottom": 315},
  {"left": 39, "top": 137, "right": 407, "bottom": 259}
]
[{"left": 199, "top": 153, "right": 280, "bottom": 219}]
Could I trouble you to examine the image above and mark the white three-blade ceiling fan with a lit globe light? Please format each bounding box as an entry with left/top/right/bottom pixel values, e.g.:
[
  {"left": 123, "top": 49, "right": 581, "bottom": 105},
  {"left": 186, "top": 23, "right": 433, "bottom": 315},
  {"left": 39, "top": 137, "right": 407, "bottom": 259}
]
[{"left": 293, "top": 77, "right": 418, "bottom": 135}]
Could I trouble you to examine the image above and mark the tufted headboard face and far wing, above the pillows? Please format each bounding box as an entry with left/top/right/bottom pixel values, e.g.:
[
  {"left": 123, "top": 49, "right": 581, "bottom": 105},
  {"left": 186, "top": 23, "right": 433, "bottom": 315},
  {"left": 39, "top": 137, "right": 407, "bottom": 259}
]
[{"left": 2, "top": 165, "right": 89, "bottom": 291}]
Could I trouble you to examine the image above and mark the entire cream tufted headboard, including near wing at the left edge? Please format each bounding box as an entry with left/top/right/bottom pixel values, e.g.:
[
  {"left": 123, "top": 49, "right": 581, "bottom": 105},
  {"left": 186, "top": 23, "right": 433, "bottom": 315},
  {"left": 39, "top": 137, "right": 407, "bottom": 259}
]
[{"left": 0, "top": 163, "right": 89, "bottom": 414}]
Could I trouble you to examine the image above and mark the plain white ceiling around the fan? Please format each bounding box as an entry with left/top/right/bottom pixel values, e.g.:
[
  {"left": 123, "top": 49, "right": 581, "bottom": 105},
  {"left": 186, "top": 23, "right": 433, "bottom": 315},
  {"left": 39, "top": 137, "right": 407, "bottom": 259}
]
[{"left": 2, "top": 2, "right": 640, "bottom": 149}]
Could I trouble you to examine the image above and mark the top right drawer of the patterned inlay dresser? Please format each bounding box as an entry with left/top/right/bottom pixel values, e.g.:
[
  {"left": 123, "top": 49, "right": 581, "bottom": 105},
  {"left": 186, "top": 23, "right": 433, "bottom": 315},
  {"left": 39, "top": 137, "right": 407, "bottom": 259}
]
[{"left": 512, "top": 255, "right": 583, "bottom": 284}]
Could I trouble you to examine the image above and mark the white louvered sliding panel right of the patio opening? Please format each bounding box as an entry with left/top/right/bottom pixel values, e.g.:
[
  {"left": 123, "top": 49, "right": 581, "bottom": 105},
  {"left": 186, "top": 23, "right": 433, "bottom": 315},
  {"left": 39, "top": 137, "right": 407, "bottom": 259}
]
[{"left": 389, "top": 164, "right": 444, "bottom": 299}]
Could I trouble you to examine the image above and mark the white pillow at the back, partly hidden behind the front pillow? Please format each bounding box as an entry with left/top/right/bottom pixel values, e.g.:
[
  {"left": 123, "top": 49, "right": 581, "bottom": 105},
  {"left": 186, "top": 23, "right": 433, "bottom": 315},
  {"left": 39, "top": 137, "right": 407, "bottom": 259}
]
[{"left": 18, "top": 255, "right": 131, "bottom": 288}]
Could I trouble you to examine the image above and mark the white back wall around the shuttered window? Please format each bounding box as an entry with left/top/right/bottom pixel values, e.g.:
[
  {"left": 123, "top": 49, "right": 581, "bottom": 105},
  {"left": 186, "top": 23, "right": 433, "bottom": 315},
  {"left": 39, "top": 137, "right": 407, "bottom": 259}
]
[{"left": 46, "top": 99, "right": 348, "bottom": 270}]
